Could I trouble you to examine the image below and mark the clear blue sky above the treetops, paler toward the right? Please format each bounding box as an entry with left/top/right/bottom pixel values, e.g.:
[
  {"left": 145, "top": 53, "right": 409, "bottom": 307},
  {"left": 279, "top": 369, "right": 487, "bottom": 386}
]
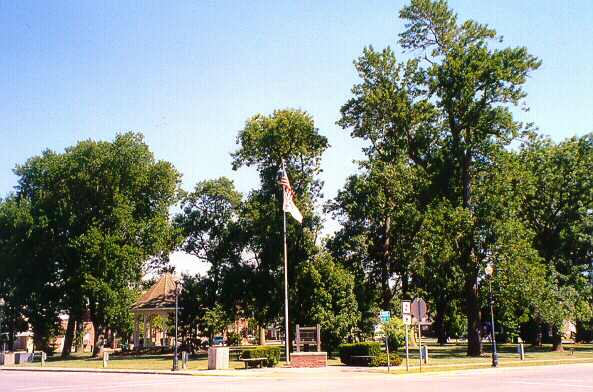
[{"left": 0, "top": 0, "right": 593, "bottom": 274}]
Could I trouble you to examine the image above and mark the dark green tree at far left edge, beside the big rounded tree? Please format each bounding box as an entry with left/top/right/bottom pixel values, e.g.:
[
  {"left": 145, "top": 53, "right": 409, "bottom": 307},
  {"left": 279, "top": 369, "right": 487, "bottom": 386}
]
[{"left": 0, "top": 195, "right": 62, "bottom": 353}]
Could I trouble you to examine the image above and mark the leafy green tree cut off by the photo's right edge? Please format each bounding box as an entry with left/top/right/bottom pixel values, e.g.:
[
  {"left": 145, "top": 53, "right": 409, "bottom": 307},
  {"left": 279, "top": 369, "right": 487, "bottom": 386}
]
[{"left": 520, "top": 134, "right": 593, "bottom": 350}]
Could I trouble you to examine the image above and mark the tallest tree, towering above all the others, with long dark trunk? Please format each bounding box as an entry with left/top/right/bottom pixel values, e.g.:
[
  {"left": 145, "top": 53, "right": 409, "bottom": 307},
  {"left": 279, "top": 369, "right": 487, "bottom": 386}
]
[{"left": 341, "top": 0, "right": 540, "bottom": 356}]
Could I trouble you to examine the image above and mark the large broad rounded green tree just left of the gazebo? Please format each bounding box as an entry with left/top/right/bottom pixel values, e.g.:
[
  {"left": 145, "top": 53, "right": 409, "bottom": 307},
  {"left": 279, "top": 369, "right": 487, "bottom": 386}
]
[{"left": 15, "top": 133, "right": 180, "bottom": 355}]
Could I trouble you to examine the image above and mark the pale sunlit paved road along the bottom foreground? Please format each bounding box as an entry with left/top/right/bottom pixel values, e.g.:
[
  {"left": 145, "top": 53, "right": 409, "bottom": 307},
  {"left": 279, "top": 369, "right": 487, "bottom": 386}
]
[{"left": 0, "top": 364, "right": 593, "bottom": 392}]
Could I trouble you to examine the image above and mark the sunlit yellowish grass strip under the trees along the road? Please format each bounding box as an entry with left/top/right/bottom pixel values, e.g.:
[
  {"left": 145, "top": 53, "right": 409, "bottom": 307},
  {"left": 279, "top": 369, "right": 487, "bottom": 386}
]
[{"left": 13, "top": 341, "right": 593, "bottom": 373}]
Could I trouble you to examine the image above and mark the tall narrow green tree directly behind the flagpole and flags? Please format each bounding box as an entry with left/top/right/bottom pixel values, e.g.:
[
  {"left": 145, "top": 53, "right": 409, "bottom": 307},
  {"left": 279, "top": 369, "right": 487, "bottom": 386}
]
[{"left": 227, "top": 109, "right": 328, "bottom": 325}]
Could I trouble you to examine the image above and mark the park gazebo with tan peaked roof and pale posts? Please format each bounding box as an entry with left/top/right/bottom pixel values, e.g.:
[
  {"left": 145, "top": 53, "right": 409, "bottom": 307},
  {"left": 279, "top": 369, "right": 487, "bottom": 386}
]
[{"left": 130, "top": 272, "right": 176, "bottom": 350}]
